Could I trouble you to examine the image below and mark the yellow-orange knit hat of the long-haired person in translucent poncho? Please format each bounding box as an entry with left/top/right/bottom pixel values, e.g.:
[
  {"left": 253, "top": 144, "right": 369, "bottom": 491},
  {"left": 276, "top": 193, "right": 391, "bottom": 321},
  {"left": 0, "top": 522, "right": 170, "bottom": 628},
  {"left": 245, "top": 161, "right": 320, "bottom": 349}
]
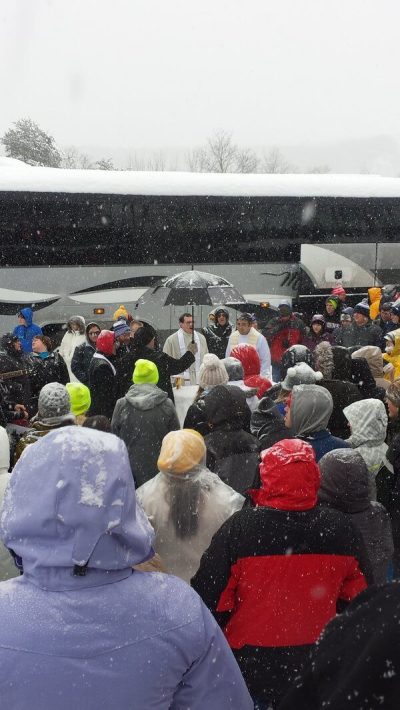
[{"left": 157, "top": 429, "right": 206, "bottom": 475}]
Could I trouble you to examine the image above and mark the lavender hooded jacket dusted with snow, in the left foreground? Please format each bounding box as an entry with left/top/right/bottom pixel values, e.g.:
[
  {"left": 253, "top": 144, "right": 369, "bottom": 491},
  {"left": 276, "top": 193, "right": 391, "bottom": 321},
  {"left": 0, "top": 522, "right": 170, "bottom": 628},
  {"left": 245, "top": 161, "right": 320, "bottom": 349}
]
[{"left": 0, "top": 427, "right": 253, "bottom": 710}]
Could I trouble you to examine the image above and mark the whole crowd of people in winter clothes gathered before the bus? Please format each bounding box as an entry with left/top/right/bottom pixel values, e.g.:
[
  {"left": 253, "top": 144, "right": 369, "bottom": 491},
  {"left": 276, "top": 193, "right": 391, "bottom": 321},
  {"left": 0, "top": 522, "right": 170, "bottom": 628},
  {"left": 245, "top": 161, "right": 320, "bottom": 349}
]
[{"left": 0, "top": 286, "right": 400, "bottom": 710}]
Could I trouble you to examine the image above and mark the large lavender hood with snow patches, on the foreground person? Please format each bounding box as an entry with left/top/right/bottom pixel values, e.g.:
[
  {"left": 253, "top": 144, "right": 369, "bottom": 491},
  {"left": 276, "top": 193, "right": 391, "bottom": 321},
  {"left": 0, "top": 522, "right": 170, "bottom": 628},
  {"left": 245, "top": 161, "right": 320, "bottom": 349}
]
[{"left": 0, "top": 426, "right": 153, "bottom": 590}]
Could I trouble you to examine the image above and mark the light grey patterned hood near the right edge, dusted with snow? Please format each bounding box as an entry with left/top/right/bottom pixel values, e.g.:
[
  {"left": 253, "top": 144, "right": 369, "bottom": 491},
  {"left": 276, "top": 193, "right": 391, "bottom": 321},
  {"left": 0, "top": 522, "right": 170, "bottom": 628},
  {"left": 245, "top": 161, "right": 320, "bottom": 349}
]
[{"left": 343, "top": 399, "right": 388, "bottom": 448}]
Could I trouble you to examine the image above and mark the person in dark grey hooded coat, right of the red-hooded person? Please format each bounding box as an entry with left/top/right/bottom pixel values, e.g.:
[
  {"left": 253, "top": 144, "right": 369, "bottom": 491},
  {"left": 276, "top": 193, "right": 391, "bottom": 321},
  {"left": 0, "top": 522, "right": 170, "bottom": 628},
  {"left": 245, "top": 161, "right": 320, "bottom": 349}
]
[{"left": 318, "top": 449, "right": 394, "bottom": 584}]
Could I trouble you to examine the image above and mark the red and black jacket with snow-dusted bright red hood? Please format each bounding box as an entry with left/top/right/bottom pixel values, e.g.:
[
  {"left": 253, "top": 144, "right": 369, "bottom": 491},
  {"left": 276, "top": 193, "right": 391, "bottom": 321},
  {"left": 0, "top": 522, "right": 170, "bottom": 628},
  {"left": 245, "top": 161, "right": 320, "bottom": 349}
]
[{"left": 192, "top": 439, "right": 366, "bottom": 700}]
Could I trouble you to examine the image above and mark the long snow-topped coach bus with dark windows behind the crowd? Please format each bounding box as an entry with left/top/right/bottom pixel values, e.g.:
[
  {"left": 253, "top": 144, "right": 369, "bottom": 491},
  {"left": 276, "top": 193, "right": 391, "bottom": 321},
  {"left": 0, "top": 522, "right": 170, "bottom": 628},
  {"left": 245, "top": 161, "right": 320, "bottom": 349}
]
[{"left": 0, "top": 160, "right": 400, "bottom": 332}]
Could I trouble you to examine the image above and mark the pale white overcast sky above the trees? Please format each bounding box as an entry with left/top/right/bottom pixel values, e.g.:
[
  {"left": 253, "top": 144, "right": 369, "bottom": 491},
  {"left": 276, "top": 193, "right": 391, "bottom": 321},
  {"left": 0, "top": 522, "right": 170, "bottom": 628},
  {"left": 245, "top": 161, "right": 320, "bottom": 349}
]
[{"left": 0, "top": 0, "right": 400, "bottom": 149}]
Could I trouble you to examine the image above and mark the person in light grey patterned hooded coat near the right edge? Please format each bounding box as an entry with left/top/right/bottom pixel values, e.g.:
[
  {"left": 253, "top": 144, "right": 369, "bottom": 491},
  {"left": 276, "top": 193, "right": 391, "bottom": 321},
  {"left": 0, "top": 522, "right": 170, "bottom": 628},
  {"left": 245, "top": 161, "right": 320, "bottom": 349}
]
[{"left": 343, "top": 399, "right": 388, "bottom": 500}]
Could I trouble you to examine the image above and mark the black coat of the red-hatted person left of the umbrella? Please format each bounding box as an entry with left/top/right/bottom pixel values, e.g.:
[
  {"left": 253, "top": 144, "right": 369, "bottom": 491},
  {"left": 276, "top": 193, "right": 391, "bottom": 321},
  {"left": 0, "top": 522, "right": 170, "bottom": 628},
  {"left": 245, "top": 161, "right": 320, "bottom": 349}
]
[{"left": 87, "top": 355, "right": 118, "bottom": 421}]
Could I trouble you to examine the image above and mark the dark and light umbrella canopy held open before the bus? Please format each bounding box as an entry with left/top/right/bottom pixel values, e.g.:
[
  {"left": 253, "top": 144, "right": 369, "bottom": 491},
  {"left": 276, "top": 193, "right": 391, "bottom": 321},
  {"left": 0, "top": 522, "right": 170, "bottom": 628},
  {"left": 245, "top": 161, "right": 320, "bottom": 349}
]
[{"left": 138, "top": 271, "right": 246, "bottom": 306}]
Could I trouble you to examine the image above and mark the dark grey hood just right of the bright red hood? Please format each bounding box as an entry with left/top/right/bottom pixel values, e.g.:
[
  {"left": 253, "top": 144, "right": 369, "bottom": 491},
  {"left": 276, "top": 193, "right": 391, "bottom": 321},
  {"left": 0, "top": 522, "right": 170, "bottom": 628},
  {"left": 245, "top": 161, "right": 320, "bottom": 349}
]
[{"left": 318, "top": 449, "right": 370, "bottom": 513}]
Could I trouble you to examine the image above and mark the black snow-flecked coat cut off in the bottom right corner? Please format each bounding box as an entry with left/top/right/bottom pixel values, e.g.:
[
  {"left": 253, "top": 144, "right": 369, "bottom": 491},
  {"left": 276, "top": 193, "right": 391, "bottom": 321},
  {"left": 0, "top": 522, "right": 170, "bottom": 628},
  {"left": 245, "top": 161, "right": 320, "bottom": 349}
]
[{"left": 279, "top": 582, "right": 400, "bottom": 710}]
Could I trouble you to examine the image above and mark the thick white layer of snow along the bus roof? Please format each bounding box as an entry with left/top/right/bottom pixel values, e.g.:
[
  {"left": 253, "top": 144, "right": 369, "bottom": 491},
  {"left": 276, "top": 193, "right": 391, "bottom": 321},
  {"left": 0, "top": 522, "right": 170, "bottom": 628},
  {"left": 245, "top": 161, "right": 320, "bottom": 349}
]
[{"left": 0, "top": 164, "right": 400, "bottom": 197}]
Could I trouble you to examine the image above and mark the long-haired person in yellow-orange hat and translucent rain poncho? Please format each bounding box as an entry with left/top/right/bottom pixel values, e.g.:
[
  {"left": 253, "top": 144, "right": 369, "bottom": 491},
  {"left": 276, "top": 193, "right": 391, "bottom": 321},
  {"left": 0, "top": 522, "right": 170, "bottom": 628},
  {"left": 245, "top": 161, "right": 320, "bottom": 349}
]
[{"left": 137, "top": 429, "right": 244, "bottom": 582}]
